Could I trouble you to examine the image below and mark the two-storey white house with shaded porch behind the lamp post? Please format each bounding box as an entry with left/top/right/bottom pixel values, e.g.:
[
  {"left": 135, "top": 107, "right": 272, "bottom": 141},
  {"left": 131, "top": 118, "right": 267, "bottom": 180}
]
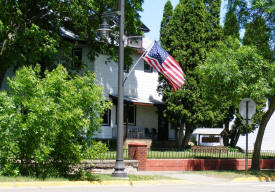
[{"left": 85, "top": 38, "right": 162, "bottom": 139}]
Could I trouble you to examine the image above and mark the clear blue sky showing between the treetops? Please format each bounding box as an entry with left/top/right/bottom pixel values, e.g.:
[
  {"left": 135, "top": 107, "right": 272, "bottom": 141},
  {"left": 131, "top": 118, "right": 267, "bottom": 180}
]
[{"left": 140, "top": 0, "right": 229, "bottom": 41}]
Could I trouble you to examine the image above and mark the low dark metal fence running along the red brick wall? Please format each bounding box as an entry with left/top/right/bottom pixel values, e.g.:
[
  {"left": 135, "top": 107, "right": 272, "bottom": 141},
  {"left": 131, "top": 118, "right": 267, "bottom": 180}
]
[{"left": 102, "top": 149, "right": 275, "bottom": 159}]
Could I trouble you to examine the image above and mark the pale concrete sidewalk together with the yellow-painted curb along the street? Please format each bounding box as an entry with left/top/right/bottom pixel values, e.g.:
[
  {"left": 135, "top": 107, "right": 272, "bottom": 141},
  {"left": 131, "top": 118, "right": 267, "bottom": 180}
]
[{"left": 0, "top": 171, "right": 275, "bottom": 188}]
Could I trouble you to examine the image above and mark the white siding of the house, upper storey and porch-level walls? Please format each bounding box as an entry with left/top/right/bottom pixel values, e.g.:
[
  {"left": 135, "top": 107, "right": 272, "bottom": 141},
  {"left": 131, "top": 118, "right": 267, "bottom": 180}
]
[{"left": 89, "top": 48, "right": 161, "bottom": 138}]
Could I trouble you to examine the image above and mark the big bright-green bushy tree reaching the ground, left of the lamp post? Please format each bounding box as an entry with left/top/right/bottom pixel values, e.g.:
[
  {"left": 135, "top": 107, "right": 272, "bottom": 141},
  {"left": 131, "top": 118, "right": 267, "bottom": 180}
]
[{"left": 0, "top": 65, "right": 110, "bottom": 177}]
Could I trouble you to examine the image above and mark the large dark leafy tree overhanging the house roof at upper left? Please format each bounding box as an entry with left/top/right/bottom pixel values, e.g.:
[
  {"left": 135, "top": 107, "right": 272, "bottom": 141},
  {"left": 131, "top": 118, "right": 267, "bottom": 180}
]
[{"left": 0, "top": 0, "right": 143, "bottom": 85}]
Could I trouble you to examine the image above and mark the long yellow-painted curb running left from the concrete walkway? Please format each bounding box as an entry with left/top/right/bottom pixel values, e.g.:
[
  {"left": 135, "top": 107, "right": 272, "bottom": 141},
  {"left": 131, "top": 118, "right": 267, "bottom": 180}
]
[{"left": 0, "top": 180, "right": 185, "bottom": 188}]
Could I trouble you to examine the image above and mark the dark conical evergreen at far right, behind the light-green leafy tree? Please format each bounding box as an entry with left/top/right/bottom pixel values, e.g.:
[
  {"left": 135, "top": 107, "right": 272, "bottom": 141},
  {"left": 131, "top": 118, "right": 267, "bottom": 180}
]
[{"left": 243, "top": 16, "right": 272, "bottom": 60}]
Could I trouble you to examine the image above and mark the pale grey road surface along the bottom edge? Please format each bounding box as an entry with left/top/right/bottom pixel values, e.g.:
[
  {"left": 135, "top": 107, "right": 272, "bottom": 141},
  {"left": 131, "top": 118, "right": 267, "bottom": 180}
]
[{"left": 0, "top": 182, "right": 275, "bottom": 192}]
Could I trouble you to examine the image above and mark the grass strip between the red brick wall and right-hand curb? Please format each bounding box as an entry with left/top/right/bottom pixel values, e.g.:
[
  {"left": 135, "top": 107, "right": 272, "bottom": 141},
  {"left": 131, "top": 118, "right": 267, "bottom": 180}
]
[{"left": 184, "top": 170, "right": 275, "bottom": 179}]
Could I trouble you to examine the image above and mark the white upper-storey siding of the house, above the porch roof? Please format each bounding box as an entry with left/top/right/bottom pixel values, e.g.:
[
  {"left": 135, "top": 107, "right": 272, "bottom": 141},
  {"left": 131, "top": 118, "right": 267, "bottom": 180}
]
[{"left": 92, "top": 51, "right": 161, "bottom": 102}]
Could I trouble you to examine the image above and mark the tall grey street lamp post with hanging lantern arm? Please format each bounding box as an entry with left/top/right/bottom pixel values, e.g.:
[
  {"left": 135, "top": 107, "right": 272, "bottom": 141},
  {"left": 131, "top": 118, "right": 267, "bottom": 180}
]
[{"left": 98, "top": 0, "right": 127, "bottom": 177}]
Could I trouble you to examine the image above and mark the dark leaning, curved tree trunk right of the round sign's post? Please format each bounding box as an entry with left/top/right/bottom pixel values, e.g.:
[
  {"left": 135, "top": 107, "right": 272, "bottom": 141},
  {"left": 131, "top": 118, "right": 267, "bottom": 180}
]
[{"left": 251, "top": 95, "right": 275, "bottom": 170}]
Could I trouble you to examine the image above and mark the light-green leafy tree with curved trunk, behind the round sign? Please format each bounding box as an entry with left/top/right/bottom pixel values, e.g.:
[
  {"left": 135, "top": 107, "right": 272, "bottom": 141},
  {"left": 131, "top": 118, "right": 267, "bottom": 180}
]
[{"left": 197, "top": 39, "right": 275, "bottom": 169}]
